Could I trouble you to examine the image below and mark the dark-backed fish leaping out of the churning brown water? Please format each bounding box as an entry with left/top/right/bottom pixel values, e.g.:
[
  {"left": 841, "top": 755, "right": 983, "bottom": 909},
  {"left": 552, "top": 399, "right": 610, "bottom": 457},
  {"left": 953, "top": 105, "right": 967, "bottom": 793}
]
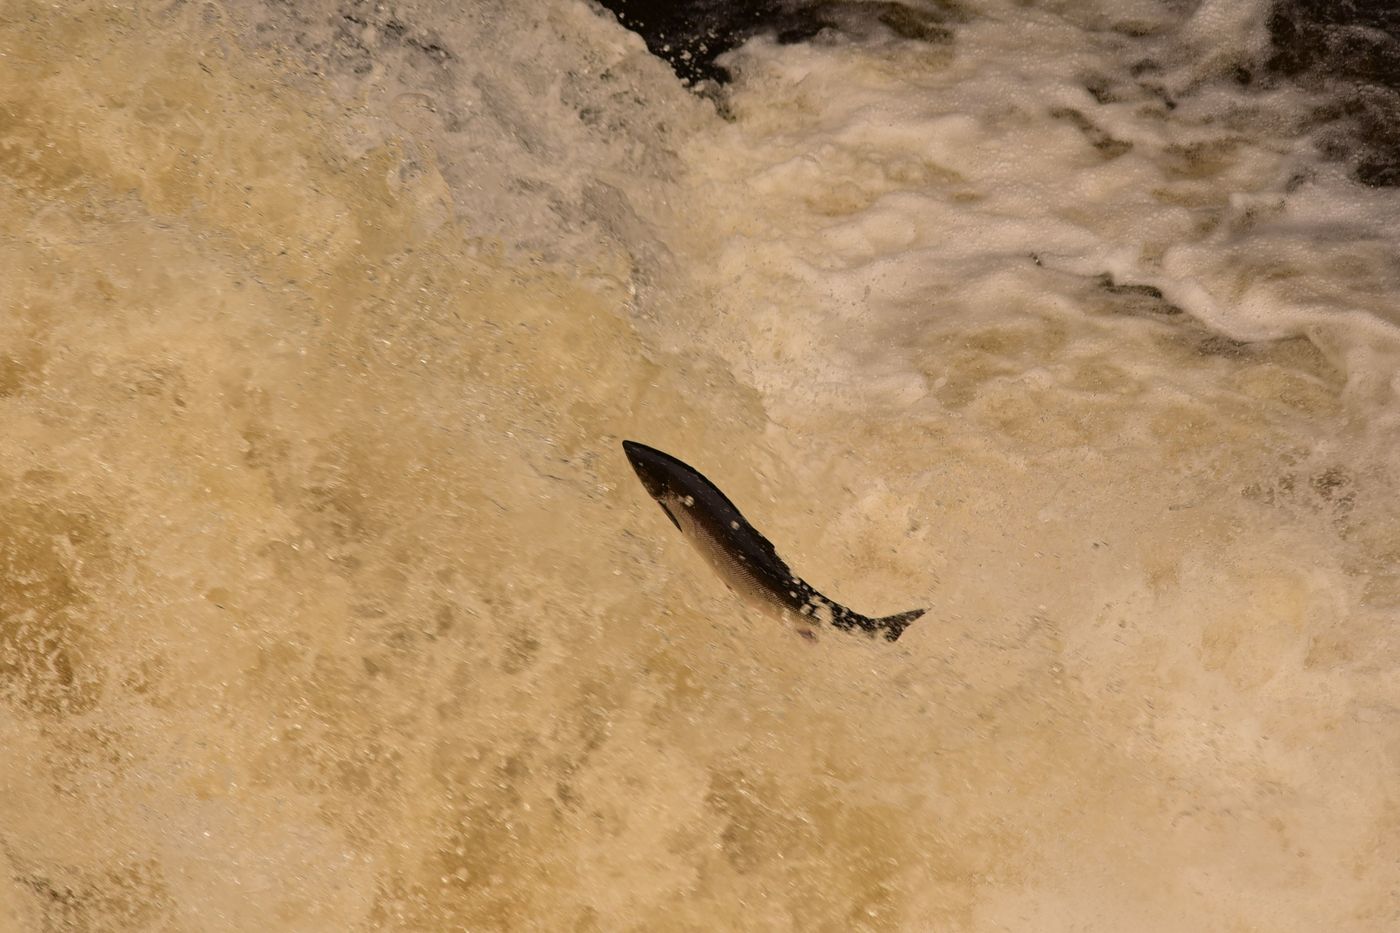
[{"left": 622, "top": 440, "right": 928, "bottom": 642}]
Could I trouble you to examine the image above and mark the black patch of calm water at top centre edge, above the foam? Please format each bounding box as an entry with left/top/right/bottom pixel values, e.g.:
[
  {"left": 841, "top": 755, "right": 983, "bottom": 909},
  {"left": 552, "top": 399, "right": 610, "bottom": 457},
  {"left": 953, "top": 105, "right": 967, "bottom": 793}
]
[{"left": 599, "top": 0, "right": 966, "bottom": 84}]
